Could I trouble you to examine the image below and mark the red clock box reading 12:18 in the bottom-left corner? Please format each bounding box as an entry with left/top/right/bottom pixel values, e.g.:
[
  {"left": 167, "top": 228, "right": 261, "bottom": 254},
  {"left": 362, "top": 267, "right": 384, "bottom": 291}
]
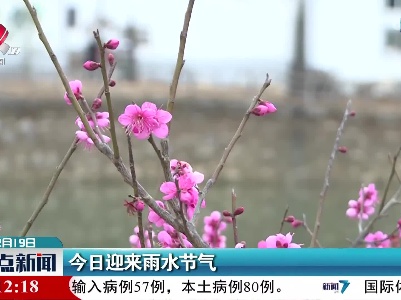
[{"left": 0, "top": 276, "right": 79, "bottom": 300}]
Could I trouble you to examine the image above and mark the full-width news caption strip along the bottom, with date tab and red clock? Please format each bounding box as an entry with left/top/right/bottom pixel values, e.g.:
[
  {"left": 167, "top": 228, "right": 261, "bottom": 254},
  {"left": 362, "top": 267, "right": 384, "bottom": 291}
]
[{"left": 0, "top": 237, "right": 401, "bottom": 300}]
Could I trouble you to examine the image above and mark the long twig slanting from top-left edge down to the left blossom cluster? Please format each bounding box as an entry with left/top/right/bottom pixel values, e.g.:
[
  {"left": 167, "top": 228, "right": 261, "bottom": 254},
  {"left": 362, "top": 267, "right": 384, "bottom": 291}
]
[{"left": 23, "top": 0, "right": 99, "bottom": 146}]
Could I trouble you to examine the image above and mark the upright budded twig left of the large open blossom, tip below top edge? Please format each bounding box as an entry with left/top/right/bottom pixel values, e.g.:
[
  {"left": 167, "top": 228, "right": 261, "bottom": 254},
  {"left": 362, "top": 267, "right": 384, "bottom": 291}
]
[{"left": 93, "top": 30, "right": 120, "bottom": 160}]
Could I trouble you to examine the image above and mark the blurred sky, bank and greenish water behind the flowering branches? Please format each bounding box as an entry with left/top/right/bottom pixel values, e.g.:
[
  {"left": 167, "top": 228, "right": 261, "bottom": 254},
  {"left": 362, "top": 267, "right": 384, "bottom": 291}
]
[{"left": 0, "top": 0, "right": 401, "bottom": 247}]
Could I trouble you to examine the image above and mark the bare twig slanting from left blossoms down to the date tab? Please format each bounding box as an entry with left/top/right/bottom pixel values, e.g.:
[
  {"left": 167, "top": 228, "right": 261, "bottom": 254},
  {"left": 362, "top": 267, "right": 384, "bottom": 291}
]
[{"left": 20, "top": 139, "right": 78, "bottom": 236}]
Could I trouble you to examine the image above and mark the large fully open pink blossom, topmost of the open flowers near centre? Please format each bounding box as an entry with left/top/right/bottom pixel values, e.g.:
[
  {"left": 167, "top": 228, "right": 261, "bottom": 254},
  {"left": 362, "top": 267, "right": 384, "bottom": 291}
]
[{"left": 118, "top": 102, "right": 172, "bottom": 139}]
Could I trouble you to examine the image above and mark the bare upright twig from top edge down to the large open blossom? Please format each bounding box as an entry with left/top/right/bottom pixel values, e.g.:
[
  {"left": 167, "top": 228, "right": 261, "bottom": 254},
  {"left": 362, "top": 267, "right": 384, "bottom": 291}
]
[{"left": 167, "top": 0, "right": 195, "bottom": 122}]
